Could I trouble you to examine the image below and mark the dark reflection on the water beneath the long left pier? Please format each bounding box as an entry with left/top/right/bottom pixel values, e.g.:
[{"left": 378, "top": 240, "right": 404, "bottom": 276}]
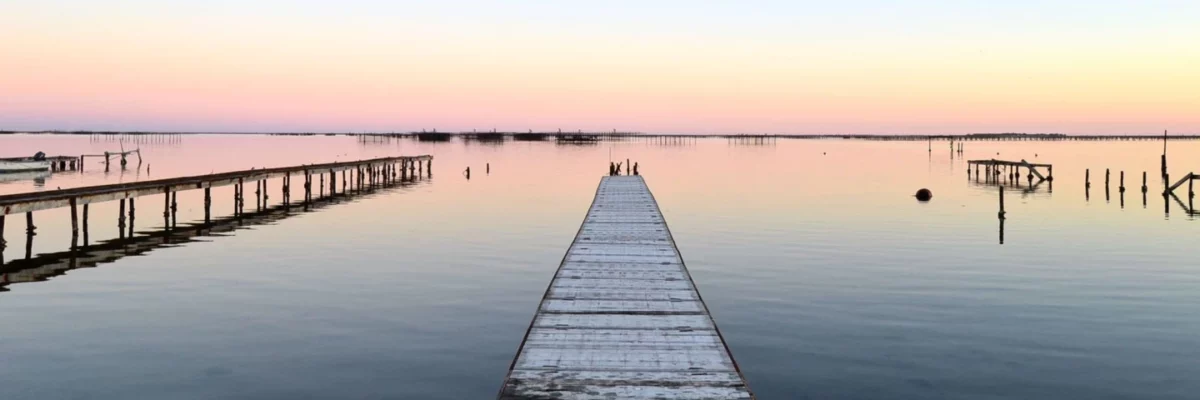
[{"left": 0, "top": 179, "right": 425, "bottom": 288}]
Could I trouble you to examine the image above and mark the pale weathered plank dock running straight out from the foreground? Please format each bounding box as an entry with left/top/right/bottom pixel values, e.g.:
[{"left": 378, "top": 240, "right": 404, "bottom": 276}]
[{"left": 499, "top": 175, "right": 754, "bottom": 400}]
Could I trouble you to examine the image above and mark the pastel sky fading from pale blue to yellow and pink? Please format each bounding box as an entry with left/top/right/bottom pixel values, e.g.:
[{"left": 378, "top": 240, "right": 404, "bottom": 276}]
[{"left": 0, "top": 0, "right": 1200, "bottom": 135}]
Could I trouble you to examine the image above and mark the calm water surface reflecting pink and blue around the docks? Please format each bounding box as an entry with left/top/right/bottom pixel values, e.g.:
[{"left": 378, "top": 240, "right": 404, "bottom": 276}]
[{"left": 0, "top": 136, "right": 1200, "bottom": 399}]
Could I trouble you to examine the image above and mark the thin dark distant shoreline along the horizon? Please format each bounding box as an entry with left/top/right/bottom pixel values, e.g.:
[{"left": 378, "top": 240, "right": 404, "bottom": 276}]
[{"left": 0, "top": 131, "right": 1200, "bottom": 142}]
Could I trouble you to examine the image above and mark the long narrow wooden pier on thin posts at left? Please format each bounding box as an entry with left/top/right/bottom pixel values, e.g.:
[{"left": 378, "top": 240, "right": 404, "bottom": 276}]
[{"left": 0, "top": 155, "right": 433, "bottom": 249}]
